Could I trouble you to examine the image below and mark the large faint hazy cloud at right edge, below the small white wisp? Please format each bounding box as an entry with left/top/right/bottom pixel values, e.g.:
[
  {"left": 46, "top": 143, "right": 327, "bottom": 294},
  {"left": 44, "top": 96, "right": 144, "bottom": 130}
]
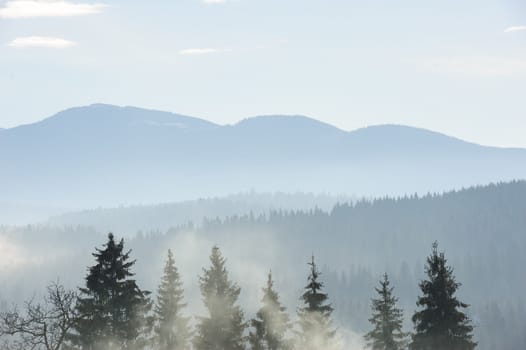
[{"left": 417, "top": 56, "right": 526, "bottom": 77}]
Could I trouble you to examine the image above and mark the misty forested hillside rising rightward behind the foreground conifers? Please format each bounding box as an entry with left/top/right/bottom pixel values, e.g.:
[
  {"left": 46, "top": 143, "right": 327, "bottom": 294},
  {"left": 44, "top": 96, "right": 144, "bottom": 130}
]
[{"left": 0, "top": 181, "right": 526, "bottom": 350}]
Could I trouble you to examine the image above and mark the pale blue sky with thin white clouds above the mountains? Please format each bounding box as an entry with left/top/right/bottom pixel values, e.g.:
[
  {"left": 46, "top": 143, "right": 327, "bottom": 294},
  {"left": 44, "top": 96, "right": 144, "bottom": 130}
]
[{"left": 0, "top": 0, "right": 526, "bottom": 148}]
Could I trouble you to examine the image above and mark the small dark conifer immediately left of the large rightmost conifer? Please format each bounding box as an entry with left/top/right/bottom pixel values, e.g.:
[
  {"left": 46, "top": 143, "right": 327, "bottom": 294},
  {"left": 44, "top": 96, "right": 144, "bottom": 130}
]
[{"left": 365, "top": 274, "right": 407, "bottom": 350}]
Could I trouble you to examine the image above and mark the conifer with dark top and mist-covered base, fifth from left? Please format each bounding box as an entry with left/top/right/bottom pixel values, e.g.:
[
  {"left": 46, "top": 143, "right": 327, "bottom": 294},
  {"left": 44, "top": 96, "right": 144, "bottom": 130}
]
[{"left": 297, "top": 256, "right": 336, "bottom": 350}]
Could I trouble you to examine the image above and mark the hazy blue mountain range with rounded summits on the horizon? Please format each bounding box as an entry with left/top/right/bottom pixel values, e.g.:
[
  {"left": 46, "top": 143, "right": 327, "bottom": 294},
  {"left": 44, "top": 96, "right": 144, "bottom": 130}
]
[{"left": 0, "top": 104, "right": 526, "bottom": 208}]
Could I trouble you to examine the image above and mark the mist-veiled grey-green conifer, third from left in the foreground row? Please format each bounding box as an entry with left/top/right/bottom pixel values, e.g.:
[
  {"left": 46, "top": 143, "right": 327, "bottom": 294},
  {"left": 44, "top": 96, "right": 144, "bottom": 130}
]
[{"left": 194, "top": 246, "right": 247, "bottom": 350}]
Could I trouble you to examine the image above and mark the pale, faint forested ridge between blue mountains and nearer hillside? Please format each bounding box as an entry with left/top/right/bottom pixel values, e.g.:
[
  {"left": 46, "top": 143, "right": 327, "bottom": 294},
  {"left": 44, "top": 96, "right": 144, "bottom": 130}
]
[{"left": 47, "top": 192, "right": 355, "bottom": 236}]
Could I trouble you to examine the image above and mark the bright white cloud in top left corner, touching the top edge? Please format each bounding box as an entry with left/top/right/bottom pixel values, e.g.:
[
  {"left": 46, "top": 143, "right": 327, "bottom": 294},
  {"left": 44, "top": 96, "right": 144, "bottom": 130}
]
[{"left": 0, "top": 0, "right": 108, "bottom": 19}]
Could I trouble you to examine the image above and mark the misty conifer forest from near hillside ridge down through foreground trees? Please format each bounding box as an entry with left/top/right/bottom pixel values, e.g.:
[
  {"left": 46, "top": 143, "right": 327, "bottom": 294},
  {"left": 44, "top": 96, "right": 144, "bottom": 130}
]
[{"left": 0, "top": 181, "right": 526, "bottom": 350}]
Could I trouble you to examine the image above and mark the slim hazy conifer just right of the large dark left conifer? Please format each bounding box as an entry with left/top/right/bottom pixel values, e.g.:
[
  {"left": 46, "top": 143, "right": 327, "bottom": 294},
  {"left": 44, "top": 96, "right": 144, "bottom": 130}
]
[{"left": 154, "top": 250, "right": 192, "bottom": 350}]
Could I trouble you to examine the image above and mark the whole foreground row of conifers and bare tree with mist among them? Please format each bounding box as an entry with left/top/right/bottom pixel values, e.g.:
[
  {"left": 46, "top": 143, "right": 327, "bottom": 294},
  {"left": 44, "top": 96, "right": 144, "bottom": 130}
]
[{"left": 0, "top": 233, "right": 477, "bottom": 350}]
